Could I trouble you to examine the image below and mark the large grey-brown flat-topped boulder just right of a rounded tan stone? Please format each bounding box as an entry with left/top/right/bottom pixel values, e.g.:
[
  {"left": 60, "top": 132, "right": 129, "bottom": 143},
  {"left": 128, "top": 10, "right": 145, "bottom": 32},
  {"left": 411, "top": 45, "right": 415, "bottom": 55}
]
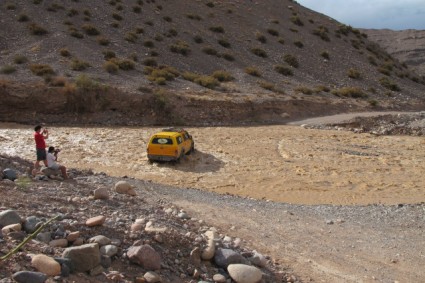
[{"left": 62, "top": 243, "right": 100, "bottom": 272}]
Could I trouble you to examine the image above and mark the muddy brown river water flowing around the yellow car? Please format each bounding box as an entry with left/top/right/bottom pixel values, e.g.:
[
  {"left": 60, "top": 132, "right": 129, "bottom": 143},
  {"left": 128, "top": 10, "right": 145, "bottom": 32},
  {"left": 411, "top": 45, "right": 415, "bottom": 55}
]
[{"left": 0, "top": 124, "right": 425, "bottom": 205}]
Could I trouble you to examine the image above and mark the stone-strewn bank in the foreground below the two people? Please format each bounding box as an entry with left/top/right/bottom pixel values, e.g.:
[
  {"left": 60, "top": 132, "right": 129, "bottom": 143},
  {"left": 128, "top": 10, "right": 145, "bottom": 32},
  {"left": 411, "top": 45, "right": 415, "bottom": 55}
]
[{"left": 0, "top": 155, "right": 288, "bottom": 282}]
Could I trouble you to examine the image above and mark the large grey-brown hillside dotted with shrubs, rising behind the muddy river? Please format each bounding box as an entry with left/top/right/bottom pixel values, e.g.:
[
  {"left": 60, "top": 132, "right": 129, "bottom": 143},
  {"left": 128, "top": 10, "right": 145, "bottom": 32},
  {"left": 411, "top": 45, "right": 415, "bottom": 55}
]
[{"left": 0, "top": 0, "right": 425, "bottom": 125}]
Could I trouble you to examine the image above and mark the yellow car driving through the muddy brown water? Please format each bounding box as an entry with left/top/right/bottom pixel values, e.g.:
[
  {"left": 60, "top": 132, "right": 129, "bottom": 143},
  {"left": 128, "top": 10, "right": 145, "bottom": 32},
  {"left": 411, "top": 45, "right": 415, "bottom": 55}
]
[{"left": 147, "top": 128, "right": 195, "bottom": 162}]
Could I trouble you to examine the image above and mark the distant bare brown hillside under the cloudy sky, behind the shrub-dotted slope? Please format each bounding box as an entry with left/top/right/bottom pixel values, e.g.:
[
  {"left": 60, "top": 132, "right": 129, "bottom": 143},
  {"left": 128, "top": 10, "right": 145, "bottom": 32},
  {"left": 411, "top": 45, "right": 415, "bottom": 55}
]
[{"left": 362, "top": 29, "right": 425, "bottom": 77}]
